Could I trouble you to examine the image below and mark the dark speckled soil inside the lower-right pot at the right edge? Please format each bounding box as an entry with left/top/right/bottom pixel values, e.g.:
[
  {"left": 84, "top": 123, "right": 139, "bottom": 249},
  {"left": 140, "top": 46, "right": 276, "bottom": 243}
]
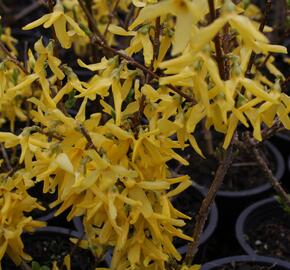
[{"left": 247, "top": 211, "right": 290, "bottom": 261}]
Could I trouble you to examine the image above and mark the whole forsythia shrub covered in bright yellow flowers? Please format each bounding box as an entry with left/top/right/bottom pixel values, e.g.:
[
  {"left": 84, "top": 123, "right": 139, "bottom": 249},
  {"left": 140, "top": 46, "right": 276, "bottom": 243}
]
[{"left": 0, "top": 0, "right": 290, "bottom": 270}]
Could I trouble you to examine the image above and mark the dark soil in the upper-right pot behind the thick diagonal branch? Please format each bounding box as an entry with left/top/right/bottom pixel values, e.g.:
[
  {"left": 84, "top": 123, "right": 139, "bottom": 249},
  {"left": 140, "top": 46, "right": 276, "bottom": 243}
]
[{"left": 178, "top": 139, "right": 276, "bottom": 191}]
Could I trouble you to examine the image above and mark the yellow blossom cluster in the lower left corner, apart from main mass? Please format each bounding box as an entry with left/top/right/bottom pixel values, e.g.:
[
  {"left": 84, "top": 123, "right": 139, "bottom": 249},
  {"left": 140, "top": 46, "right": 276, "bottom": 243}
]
[{"left": 0, "top": 171, "right": 45, "bottom": 269}]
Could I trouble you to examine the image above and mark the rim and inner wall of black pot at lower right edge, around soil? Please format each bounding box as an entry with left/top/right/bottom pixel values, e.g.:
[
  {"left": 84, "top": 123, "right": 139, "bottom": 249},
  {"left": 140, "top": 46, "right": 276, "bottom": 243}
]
[{"left": 236, "top": 197, "right": 290, "bottom": 260}]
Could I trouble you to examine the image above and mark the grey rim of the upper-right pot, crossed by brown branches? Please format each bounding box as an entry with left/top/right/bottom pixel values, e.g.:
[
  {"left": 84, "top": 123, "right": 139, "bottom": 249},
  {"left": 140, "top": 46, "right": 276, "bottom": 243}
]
[{"left": 195, "top": 141, "right": 285, "bottom": 198}]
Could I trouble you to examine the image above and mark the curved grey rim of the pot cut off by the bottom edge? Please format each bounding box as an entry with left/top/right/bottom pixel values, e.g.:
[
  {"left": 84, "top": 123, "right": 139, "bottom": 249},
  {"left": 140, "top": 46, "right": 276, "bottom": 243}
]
[{"left": 201, "top": 255, "right": 290, "bottom": 270}]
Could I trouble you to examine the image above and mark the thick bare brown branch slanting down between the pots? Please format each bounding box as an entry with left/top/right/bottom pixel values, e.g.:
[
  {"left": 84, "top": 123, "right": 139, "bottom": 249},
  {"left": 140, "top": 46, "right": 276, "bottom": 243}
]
[{"left": 184, "top": 143, "right": 233, "bottom": 266}]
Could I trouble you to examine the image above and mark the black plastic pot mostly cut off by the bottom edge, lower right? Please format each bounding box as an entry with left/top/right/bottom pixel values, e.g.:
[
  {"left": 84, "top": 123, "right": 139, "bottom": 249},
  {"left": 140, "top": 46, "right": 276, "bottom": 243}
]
[{"left": 201, "top": 255, "right": 290, "bottom": 270}]
